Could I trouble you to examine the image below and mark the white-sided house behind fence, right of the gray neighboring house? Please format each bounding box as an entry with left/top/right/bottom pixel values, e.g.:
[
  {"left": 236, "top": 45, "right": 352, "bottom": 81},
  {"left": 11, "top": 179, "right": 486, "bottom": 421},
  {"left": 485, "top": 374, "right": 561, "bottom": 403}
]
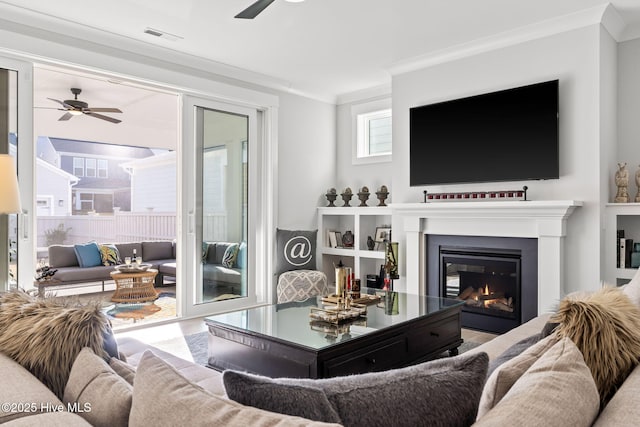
[{"left": 120, "top": 151, "right": 176, "bottom": 212}]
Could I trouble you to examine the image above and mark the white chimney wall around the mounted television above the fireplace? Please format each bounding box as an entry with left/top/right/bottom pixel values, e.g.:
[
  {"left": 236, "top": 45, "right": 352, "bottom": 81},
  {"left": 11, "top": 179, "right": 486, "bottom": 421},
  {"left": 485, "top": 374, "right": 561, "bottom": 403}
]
[{"left": 339, "top": 25, "right": 615, "bottom": 292}]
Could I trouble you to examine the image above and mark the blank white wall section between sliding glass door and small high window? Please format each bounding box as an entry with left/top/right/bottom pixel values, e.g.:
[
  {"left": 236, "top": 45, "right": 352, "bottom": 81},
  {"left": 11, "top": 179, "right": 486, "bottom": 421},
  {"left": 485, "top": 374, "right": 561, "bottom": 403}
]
[{"left": 277, "top": 94, "right": 337, "bottom": 230}]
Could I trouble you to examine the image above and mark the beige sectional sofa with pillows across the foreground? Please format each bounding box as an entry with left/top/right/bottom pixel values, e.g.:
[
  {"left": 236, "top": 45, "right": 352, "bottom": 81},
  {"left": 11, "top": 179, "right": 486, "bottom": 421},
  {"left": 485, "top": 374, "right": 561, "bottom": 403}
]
[{"left": 5, "top": 279, "right": 640, "bottom": 427}]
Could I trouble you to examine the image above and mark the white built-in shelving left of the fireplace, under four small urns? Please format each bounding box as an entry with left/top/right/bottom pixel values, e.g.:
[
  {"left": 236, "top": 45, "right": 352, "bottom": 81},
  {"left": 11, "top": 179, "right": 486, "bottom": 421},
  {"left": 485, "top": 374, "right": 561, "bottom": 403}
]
[{"left": 317, "top": 206, "right": 391, "bottom": 287}]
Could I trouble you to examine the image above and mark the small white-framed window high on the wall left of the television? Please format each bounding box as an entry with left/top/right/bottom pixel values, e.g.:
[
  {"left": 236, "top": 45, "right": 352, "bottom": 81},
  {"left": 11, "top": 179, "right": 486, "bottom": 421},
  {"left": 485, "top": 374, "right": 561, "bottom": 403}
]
[{"left": 351, "top": 99, "right": 392, "bottom": 164}]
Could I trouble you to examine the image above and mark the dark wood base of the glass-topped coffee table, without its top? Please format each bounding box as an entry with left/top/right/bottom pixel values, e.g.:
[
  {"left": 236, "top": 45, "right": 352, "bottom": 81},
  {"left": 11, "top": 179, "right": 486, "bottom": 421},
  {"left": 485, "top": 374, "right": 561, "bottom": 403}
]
[{"left": 207, "top": 306, "right": 463, "bottom": 378}]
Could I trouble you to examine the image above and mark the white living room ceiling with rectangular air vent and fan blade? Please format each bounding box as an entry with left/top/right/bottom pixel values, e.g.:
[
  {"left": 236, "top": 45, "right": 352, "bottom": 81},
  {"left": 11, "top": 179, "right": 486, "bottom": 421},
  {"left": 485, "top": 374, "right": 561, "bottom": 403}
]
[{"left": 0, "top": 0, "right": 640, "bottom": 106}]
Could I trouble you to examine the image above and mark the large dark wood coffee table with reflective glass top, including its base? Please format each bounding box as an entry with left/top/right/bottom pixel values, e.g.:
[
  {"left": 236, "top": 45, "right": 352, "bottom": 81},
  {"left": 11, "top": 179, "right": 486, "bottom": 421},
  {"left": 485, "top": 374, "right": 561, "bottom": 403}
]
[{"left": 205, "top": 292, "right": 463, "bottom": 378}]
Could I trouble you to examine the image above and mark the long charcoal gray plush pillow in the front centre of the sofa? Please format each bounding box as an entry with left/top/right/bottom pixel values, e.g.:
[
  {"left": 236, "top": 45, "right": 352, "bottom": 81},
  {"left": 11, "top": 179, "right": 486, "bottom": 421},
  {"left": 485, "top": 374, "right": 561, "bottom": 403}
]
[{"left": 222, "top": 353, "right": 489, "bottom": 427}]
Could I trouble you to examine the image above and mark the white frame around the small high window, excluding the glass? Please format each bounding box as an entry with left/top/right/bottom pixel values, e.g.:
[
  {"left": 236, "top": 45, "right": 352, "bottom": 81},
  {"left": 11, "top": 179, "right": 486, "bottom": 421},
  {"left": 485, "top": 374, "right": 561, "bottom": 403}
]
[{"left": 351, "top": 98, "right": 393, "bottom": 165}]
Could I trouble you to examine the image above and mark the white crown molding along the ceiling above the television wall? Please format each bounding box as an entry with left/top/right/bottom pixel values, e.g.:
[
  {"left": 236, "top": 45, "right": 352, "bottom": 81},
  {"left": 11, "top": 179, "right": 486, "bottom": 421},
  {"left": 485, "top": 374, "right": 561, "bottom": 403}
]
[{"left": 388, "top": 3, "right": 624, "bottom": 76}]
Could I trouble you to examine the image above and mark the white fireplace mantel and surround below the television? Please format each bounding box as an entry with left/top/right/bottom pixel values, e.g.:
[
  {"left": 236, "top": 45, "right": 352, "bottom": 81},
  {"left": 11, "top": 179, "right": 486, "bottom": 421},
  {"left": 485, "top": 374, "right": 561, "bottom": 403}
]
[{"left": 390, "top": 200, "right": 582, "bottom": 313}]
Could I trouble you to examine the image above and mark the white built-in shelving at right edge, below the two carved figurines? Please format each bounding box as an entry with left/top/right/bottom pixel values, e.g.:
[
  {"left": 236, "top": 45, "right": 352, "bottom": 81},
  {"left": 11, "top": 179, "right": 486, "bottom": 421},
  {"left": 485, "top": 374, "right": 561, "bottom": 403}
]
[{"left": 604, "top": 203, "right": 640, "bottom": 285}]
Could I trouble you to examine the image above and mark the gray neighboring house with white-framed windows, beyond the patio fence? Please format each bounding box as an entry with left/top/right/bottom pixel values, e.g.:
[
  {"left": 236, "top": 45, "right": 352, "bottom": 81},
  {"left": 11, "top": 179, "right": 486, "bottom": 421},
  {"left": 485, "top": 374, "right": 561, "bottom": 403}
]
[{"left": 37, "top": 137, "right": 154, "bottom": 215}]
